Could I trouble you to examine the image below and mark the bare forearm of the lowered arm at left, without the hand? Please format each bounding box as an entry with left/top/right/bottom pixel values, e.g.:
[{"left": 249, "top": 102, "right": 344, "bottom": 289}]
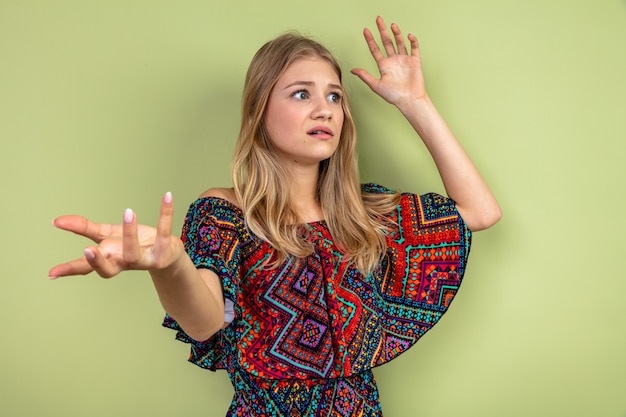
[{"left": 150, "top": 255, "right": 224, "bottom": 341}]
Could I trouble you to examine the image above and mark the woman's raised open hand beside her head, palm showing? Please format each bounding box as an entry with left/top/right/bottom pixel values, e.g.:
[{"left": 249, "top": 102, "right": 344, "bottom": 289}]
[{"left": 351, "top": 16, "right": 427, "bottom": 107}]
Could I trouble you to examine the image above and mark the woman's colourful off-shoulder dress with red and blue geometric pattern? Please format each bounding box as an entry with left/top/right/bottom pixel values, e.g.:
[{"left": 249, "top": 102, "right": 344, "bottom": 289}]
[{"left": 164, "top": 184, "right": 471, "bottom": 417}]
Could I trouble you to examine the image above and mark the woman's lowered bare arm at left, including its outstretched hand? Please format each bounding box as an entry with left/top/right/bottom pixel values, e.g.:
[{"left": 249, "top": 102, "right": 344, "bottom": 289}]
[{"left": 48, "top": 193, "right": 224, "bottom": 341}]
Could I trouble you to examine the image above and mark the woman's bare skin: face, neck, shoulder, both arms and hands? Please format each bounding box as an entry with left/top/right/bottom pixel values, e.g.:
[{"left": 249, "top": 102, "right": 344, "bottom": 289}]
[{"left": 49, "top": 17, "right": 501, "bottom": 340}]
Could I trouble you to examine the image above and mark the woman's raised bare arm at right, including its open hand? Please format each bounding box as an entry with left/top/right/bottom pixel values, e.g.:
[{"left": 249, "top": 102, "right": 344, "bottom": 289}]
[{"left": 352, "top": 17, "right": 502, "bottom": 231}]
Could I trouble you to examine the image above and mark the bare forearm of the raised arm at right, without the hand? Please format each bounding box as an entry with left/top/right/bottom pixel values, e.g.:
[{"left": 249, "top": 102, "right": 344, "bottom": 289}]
[{"left": 398, "top": 96, "right": 501, "bottom": 231}]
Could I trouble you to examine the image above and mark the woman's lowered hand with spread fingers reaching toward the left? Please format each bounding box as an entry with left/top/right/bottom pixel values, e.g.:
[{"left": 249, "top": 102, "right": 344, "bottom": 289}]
[{"left": 48, "top": 193, "right": 184, "bottom": 279}]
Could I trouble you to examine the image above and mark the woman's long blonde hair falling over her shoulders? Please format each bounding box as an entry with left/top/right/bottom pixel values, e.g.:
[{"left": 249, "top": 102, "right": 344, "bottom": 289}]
[{"left": 232, "top": 33, "right": 398, "bottom": 274}]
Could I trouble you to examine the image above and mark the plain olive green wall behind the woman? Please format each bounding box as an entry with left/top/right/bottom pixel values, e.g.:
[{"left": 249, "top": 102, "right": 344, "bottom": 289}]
[{"left": 0, "top": 0, "right": 626, "bottom": 417}]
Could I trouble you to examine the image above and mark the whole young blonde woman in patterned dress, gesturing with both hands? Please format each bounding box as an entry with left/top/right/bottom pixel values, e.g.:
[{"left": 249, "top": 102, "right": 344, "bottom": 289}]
[{"left": 50, "top": 18, "right": 501, "bottom": 416}]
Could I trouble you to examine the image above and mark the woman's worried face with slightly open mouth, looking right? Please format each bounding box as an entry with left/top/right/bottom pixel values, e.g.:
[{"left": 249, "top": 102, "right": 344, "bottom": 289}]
[{"left": 265, "top": 57, "right": 344, "bottom": 166}]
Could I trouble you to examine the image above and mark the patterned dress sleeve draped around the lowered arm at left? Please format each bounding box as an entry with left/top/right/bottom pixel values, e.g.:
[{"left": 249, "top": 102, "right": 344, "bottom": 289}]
[{"left": 163, "top": 198, "right": 244, "bottom": 370}]
